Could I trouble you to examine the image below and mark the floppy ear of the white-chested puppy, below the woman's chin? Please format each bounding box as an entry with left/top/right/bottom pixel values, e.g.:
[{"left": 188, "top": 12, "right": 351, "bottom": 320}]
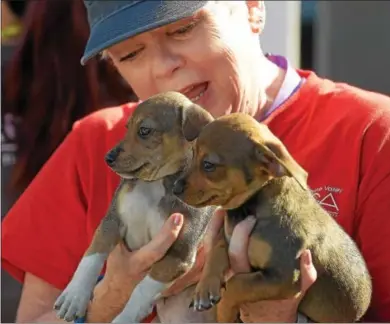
[{"left": 182, "top": 104, "right": 214, "bottom": 142}]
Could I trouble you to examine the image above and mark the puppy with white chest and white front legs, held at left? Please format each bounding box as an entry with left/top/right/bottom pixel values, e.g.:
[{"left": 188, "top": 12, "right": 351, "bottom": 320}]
[{"left": 55, "top": 92, "right": 215, "bottom": 323}]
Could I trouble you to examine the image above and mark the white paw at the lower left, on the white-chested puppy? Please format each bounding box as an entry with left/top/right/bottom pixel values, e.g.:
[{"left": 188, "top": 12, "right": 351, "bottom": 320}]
[{"left": 54, "top": 286, "right": 92, "bottom": 322}]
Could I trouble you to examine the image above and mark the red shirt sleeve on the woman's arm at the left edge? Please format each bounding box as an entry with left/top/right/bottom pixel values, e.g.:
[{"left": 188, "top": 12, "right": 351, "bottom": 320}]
[{"left": 2, "top": 123, "right": 90, "bottom": 289}]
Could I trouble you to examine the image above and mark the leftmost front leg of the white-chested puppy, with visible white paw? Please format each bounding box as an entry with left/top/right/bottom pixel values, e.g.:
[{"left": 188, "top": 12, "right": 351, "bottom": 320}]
[{"left": 54, "top": 207, "right": 120, "bottom": 322}]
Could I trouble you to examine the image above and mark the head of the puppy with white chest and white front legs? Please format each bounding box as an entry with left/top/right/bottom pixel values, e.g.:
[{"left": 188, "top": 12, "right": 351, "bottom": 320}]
[{"left": 106, "top": 92, "right": 213, "bottom": 181}]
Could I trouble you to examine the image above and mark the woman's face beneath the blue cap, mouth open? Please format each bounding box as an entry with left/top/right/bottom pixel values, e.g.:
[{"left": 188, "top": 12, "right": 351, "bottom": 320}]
[{"left": 108, "top": 1, "right": 260, "bottom": 117}]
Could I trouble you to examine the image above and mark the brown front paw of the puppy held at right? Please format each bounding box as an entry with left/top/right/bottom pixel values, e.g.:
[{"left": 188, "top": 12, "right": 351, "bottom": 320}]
[{"left": 190, "top": 276, "right": 225, "bottom": 311}]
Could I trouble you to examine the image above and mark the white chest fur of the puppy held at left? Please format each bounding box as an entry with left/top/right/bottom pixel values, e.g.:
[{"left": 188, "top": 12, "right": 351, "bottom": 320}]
[{"left": 118, "top": 180, "right": 169, "bottom": 250}]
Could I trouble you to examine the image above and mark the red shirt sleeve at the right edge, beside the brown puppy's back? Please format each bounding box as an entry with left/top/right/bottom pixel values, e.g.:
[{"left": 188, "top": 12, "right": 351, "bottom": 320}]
[{"left": 355, "top": 110, "right": 390, "bottom": 322}]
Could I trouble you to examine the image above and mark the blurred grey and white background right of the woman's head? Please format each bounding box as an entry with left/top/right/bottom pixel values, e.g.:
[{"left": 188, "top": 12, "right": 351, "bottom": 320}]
[{"left": 262, "top": 0, "right": 390, "bottom": 95}]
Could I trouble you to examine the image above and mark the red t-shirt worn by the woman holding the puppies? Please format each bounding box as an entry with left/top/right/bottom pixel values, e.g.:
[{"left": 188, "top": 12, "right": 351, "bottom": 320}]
[{"left": 2, "top": 71, "right": 390, "bottom": 322}]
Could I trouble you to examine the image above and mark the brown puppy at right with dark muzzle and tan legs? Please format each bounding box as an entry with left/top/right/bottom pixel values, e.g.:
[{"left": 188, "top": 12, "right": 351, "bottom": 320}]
[{"left": 174, "top": 113, "right": 372, "bottom": 323}]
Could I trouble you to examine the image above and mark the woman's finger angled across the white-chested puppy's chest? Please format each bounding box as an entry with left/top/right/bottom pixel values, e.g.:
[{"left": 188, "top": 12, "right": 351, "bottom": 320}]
[{"left": 131, "top": 214, "right": 184, "bottom": 272}]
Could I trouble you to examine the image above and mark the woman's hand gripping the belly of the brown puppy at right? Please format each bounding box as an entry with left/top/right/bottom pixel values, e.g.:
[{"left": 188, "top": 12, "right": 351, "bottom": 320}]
[{"left": 229, "top": 217, "right": 317, "bottom": 323}]
